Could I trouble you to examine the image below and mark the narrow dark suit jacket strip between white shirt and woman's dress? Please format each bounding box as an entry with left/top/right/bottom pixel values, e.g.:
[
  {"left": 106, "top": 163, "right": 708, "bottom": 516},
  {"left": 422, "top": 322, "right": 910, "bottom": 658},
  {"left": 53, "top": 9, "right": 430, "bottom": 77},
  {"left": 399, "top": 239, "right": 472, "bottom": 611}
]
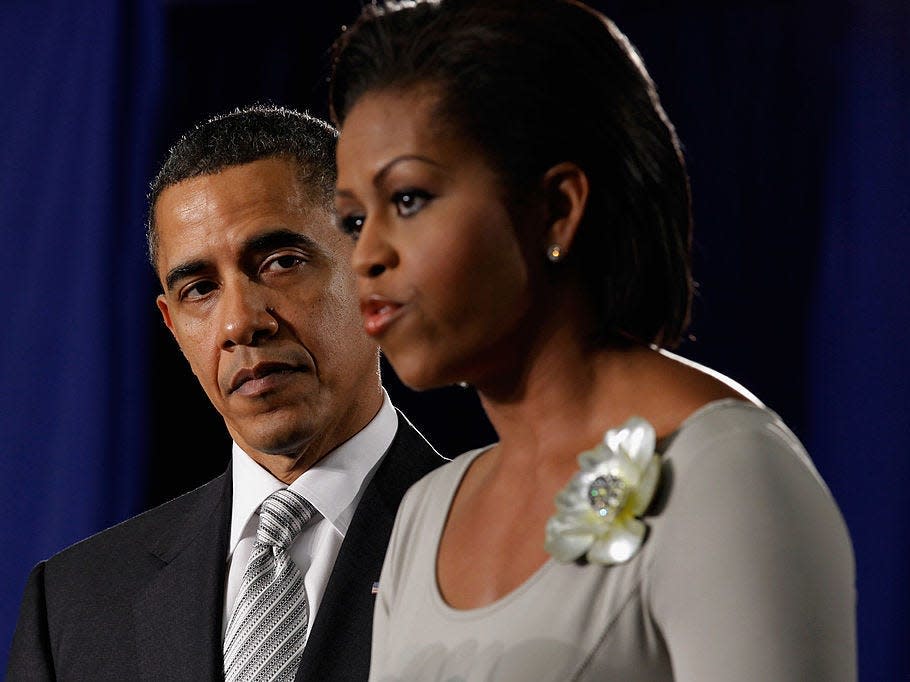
[{"left": 296, "top": 412, "right": 445, "bottom": 682}]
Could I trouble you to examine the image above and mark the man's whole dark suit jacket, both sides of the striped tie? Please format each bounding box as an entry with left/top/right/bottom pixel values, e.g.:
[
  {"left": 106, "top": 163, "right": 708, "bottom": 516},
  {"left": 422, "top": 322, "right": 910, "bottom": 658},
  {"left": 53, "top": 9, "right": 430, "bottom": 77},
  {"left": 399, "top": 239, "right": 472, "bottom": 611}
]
[{"left": 7, "top": 413, "right": 444, "bottom": 682}]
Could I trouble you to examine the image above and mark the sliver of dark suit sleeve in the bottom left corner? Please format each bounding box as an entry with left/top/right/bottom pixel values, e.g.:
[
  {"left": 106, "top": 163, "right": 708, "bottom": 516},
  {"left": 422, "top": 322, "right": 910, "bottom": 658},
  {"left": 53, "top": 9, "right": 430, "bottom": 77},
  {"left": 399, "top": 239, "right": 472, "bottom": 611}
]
[{"left": 6, "top": 562, "right": 55, "bottom": 682}]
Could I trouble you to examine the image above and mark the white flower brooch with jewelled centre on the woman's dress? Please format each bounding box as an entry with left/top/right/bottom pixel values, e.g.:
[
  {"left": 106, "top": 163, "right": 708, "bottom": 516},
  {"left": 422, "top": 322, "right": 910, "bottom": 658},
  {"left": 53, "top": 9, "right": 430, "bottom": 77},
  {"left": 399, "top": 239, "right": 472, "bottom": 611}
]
[{"left": 544, "top": 417, "right": 660, "bottom": 565}]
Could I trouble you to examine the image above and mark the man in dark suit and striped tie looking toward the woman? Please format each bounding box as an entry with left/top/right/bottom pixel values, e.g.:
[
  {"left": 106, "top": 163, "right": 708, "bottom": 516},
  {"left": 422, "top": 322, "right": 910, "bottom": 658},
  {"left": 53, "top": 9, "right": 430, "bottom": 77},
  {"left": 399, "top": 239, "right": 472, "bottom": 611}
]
[{"left": 8, "top": 107, "right": 442, "bottom": 682}]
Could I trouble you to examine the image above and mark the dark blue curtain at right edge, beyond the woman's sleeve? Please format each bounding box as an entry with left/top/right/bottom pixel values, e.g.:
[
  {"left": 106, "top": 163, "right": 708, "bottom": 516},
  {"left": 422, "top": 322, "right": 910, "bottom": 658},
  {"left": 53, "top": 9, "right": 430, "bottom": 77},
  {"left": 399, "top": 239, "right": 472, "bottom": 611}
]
[{"left": 806, "top": 1, "right": 910, "bottom": 668}]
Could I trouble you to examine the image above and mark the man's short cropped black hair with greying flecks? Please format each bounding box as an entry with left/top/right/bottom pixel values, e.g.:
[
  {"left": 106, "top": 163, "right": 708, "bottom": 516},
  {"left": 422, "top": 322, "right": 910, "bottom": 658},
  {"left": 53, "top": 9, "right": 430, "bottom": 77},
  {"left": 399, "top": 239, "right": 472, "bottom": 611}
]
[{"left": 146, "top": 104, "right": 338, "bottom": 269}]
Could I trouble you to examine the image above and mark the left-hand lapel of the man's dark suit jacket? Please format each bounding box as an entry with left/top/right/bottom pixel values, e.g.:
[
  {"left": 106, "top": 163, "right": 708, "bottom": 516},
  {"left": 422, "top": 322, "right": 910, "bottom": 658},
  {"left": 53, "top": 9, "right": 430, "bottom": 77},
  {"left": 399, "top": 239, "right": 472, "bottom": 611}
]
[{"left": 133, "top": 468, "right": 232, "bottom": 680}]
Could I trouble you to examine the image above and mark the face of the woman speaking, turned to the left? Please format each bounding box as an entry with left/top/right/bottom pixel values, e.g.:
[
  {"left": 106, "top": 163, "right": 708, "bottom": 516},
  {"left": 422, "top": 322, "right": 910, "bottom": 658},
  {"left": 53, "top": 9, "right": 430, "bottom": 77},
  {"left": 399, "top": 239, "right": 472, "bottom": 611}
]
[{"left": 336, "top": 89, "right": 543, "bottom": 389}]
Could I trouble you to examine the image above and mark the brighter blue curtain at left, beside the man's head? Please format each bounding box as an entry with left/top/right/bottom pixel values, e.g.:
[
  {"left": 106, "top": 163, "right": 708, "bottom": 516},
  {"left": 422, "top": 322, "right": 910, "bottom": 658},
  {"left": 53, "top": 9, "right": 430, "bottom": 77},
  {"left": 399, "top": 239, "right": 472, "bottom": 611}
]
[{"left": 0, "top": 0, "right": 161, "bottom": 669}]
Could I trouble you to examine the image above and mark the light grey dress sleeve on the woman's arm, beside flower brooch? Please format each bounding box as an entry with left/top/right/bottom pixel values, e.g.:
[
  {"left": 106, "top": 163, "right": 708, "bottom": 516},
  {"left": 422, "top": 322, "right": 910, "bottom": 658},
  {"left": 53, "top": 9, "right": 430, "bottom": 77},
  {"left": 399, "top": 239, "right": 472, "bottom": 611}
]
[{"left": 647, "top": 424, "right": 856, "bottom": 682}]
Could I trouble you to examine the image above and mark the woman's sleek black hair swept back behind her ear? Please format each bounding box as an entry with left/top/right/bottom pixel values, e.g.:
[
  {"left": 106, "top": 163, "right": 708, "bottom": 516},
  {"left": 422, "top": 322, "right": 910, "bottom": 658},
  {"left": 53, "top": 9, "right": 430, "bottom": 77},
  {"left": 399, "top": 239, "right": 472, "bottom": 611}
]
[{"left": 330, "top": 0, "right": 693, "bottom": 347}]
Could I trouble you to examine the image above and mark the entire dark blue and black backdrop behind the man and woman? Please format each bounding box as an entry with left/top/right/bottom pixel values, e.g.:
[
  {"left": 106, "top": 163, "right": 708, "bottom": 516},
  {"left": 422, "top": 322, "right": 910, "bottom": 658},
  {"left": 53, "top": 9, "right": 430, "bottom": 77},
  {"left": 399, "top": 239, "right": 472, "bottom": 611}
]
[{"left": 0, "top": 0, "right": 910, "bottom": 681}]
